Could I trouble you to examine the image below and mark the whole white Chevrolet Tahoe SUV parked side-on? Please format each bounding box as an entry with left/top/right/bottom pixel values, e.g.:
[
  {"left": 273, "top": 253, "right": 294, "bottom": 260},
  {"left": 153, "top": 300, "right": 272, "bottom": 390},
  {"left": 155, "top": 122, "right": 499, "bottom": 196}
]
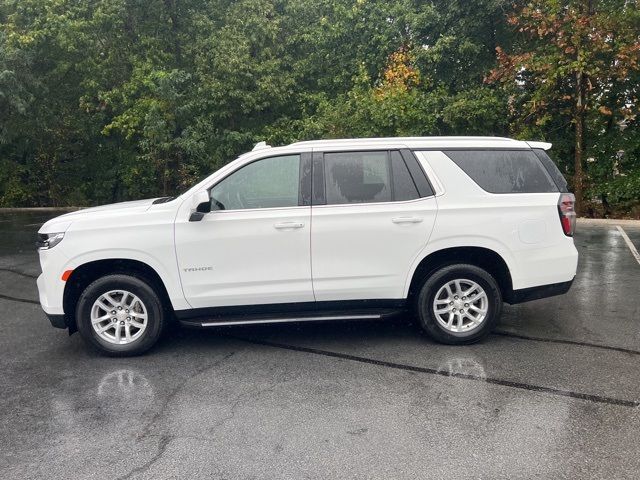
[{"left": 38, "top": 137, "right": 578, "bottom": 355}]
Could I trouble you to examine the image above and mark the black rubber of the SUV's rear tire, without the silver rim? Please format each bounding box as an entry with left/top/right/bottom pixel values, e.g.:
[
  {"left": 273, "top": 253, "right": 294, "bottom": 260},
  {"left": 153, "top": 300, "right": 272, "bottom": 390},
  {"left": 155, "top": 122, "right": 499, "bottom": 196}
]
[{"left": 415, "top": 264, "right": 502, "bottom": 345}]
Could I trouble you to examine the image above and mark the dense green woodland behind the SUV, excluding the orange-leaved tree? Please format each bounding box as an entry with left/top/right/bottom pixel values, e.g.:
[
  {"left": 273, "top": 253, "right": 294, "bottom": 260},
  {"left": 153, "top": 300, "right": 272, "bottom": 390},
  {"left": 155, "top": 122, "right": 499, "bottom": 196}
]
[{"left": 0, "top": 0, "right": 640, "bottom": 214}]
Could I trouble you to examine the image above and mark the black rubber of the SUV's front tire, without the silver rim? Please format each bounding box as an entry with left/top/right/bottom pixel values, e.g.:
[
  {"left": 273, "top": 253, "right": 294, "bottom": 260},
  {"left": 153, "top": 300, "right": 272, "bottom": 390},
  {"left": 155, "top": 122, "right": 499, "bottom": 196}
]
[{"left": 76, "top": 274, "right": 166, "bottom": 357}]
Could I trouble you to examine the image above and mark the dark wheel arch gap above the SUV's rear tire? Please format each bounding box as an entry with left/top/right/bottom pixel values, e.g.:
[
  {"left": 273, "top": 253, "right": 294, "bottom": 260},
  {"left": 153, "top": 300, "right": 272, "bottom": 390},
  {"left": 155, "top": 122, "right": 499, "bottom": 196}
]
[{"left": 407, "top": 246, "right": 513, "bottom": 302}]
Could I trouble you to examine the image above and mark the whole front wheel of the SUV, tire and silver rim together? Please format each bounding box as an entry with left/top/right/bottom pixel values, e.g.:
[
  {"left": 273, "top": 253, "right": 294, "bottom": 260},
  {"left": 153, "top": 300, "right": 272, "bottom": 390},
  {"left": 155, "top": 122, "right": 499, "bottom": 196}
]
[{"left": 76, "top": 274, "right": 166, "bottom": 357}]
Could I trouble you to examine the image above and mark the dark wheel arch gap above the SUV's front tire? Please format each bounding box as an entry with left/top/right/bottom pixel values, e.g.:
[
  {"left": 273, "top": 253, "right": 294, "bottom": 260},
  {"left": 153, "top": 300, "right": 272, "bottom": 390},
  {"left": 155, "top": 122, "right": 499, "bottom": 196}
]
[{"left": 62, "top": 258, "right": 173, "bottom": 333}]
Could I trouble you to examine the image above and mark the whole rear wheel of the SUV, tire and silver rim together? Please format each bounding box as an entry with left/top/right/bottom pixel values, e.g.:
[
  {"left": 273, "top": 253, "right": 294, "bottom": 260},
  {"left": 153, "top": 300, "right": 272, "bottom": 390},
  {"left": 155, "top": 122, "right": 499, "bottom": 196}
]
[{"left": 415, "top": 264, "right": 502, "bottom": 345}]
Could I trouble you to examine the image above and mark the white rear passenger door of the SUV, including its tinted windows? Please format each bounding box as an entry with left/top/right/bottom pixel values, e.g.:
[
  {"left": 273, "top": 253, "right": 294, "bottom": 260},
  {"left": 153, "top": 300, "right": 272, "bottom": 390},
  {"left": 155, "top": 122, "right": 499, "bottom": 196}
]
[{"left": 311, "top": 150, "right": 437, "bottom": 301}]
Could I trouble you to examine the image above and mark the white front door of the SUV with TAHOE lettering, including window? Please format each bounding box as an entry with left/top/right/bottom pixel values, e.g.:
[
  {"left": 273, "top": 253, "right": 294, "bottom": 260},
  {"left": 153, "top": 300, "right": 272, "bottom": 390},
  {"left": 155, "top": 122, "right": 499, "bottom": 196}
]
[{"left": 175, "top": 154, "right": 314, "bottom": 308}]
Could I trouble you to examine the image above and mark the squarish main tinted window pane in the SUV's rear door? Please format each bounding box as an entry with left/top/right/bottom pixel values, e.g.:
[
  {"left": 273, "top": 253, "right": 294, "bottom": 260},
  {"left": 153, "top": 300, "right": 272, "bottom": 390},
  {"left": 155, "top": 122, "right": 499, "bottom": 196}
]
[{"left": 324, "top": 151, "right": 391, "bottom": 205}]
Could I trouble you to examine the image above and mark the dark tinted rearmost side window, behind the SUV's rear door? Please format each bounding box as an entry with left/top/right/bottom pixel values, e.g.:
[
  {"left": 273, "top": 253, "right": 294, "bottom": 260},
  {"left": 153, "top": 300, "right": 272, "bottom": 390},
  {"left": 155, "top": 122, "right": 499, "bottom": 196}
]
[{"left": 444, "top": 150, "right": 558, "bottom": 193}]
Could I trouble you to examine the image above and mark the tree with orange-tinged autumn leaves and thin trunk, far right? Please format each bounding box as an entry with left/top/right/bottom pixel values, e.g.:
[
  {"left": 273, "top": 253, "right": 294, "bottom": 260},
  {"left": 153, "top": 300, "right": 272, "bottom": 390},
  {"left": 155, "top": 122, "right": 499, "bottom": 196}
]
[{"left": 487, "top": 0, "right": 640, "bottom": 213}]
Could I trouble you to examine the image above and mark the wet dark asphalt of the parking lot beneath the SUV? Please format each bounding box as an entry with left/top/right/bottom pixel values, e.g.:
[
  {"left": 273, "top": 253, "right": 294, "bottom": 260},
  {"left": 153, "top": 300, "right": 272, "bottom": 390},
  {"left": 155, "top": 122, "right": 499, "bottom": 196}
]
[{"left": 0, "top": 213, "right": 640, "bottom": 479}]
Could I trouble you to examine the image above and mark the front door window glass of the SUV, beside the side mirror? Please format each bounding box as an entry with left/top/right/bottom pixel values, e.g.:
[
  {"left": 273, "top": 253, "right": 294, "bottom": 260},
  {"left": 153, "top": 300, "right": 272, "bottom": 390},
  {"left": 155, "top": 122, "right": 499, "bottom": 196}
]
[{"left": 210, "top": 155, "right": 300, "bottom": 210}]
